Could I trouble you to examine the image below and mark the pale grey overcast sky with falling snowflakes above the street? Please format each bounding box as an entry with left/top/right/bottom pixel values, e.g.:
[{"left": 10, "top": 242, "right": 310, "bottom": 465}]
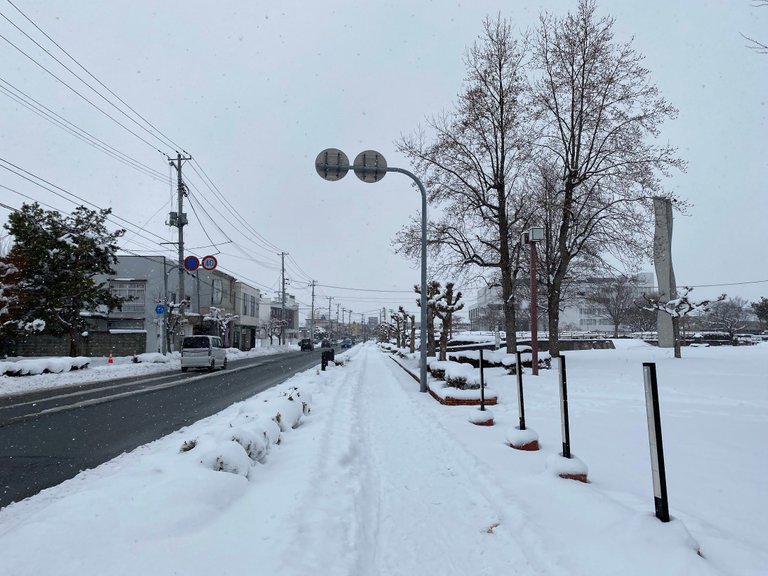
[{"left": 0, "top": 0, "right": 768, "bottom": 318}]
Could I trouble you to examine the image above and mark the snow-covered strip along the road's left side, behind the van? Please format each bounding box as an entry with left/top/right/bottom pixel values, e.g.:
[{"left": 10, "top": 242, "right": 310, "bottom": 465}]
[{"left": 0, "top": 345, "right": 299, "bottom": 396}]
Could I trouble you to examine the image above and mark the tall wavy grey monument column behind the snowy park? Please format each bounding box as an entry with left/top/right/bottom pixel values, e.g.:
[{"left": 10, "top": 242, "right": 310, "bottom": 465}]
[{"left": 653, "top": 197, "right": 677, "bottom": 348}]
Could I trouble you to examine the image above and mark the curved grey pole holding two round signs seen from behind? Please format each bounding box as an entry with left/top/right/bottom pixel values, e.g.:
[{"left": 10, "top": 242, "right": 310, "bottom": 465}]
[{"left": 315, "top": 148, "right": 427, "bottom": 392}]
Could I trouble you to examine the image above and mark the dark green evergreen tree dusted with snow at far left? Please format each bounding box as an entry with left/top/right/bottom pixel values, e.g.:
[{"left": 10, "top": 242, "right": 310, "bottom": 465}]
[{"left": 3, "top": 202, "right": 125, "bottom": 356}]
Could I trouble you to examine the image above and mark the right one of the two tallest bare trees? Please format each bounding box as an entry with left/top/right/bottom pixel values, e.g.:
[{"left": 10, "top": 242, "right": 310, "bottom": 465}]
[{"left": 533, "top": 0, "right": 684, "bottom": 356}]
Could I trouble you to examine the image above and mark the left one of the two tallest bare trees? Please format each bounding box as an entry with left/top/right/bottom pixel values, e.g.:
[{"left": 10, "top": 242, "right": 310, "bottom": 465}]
[{"left": 395, "top": 16, "right": 532, "bottom": 351}]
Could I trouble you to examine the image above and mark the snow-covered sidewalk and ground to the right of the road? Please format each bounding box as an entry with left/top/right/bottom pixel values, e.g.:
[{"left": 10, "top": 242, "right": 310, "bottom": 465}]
[{"left": 0, "top": 342, "right": 768, "bottom": 576}]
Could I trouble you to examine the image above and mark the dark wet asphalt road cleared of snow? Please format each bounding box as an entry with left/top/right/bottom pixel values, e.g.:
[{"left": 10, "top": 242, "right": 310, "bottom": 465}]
[{"left": 0, "top": 350, "right": 320, "bottom": 508}]
